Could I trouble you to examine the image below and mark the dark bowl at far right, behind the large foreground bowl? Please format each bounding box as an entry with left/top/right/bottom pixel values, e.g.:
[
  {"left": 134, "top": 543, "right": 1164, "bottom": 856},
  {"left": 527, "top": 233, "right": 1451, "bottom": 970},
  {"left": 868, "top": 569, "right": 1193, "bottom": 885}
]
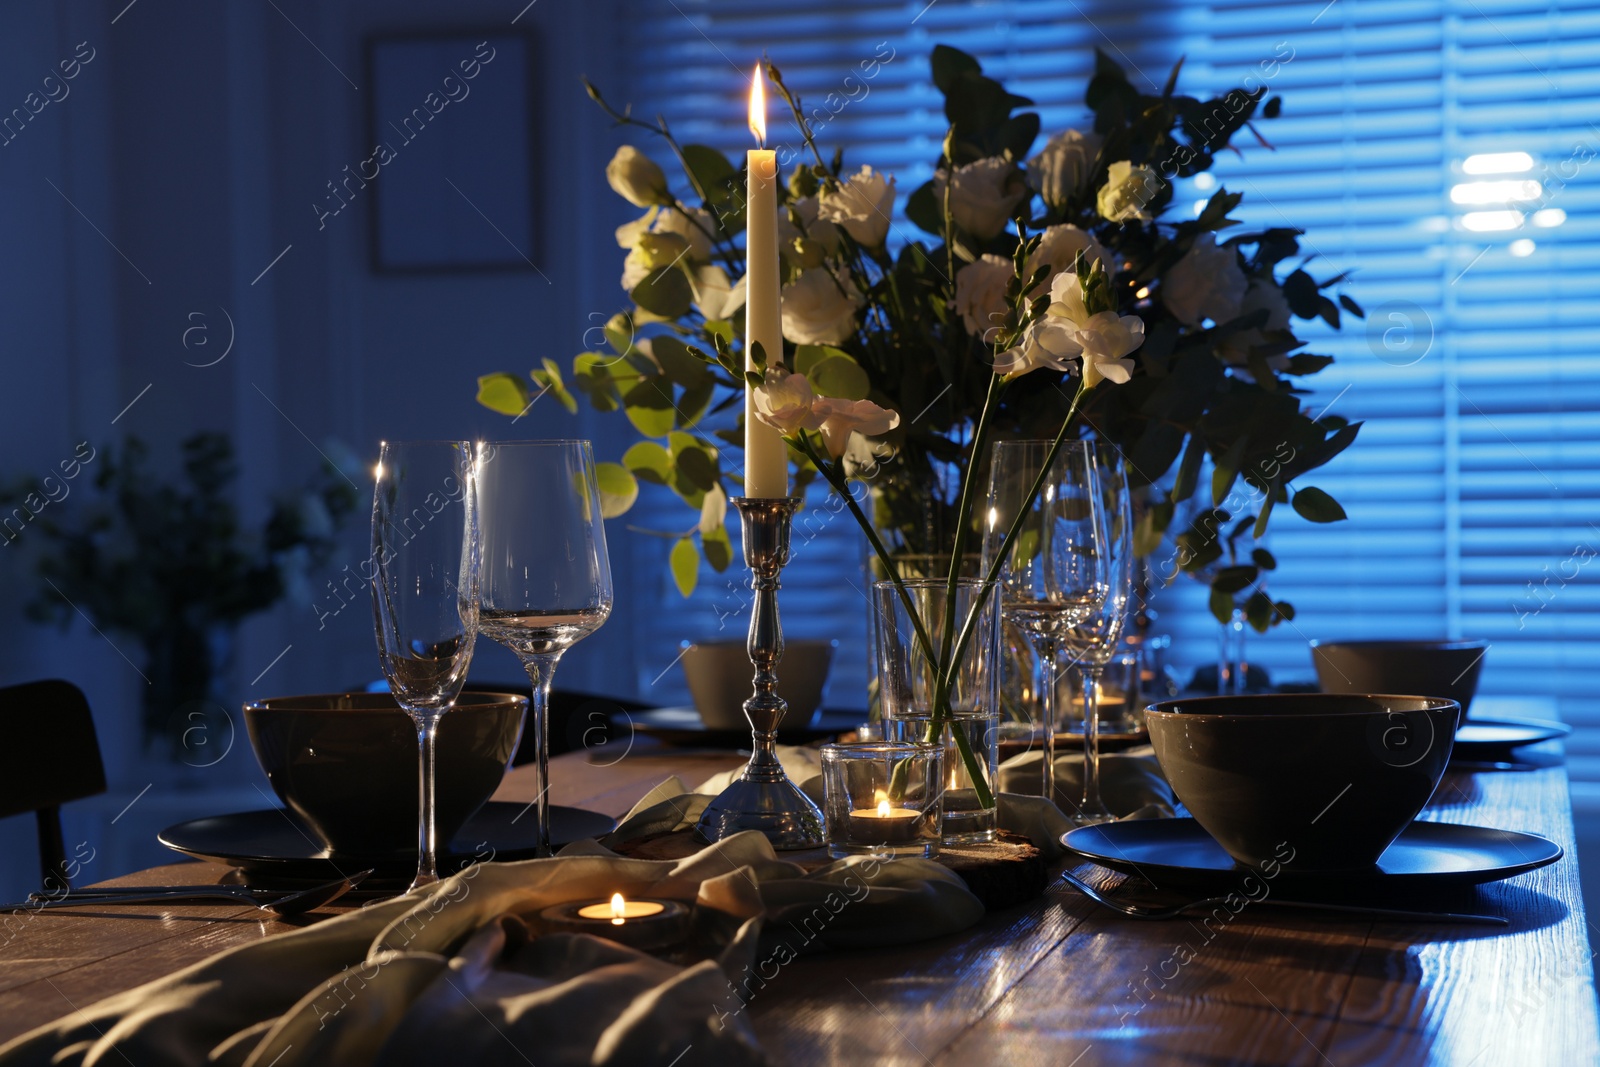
[{"left": 1310, "top": 640, "right": 1488, "bottom": 720}]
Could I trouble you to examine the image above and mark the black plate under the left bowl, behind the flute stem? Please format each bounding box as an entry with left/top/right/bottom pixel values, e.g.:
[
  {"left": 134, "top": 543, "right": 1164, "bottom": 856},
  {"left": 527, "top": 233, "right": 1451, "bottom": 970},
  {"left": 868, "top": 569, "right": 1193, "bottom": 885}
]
[{"left": 157, "top": 800, "right": 616, "bottom": 880}]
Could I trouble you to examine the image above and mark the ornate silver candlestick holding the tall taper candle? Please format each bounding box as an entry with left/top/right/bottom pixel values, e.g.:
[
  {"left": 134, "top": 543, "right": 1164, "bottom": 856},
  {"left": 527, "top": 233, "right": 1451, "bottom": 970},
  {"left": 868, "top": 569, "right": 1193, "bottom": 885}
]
[{"left": 694, "top": 496, "right": 826, "bottom": 849}]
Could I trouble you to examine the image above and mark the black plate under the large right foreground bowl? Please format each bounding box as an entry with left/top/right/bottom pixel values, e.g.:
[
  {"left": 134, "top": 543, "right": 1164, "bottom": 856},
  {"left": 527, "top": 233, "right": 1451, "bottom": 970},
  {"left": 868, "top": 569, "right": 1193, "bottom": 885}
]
[{"left": 1061, "top": 819, "right": 1562, "bottom": 893}]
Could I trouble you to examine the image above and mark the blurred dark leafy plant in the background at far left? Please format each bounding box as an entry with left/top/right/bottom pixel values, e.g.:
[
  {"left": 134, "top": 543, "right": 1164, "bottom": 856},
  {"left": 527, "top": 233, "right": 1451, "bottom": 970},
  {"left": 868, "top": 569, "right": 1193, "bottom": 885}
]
[{"left": 0, "top": 434, "right": 362, "bottom": 752}]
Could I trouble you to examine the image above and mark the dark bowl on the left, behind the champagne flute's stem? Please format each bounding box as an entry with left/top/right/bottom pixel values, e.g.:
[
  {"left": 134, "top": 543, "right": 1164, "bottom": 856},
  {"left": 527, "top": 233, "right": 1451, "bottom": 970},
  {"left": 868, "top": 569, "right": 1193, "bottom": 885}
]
[{"left": 245, "top": 693, "right": 528, "bottom": 857}]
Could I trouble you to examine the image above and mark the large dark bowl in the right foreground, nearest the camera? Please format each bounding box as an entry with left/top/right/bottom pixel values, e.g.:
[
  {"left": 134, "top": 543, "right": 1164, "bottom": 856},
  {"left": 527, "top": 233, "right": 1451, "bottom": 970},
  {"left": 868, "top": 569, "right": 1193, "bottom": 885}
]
[{"left": 1146, "top": 693, "right": 1461, "bottom": 872}]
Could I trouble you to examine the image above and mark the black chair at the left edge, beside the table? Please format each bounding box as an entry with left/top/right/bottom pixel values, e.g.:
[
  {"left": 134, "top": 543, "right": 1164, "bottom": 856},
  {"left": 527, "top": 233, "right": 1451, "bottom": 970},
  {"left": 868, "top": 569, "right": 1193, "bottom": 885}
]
[{"left": 0, "top": 680, "right": 106, "bottom": 893}]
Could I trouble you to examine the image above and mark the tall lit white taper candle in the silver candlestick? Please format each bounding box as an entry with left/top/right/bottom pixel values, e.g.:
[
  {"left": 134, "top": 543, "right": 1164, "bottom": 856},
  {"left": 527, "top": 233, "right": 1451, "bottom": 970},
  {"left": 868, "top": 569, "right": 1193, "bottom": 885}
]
[{"left": 744, "top": 66, "right": 789, "bottom": 498}]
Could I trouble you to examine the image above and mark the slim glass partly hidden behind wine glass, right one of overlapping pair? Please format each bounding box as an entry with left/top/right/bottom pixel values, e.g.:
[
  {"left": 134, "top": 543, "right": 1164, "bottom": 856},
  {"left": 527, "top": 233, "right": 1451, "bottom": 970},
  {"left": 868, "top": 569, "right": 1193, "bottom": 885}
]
[{"left": 1062, "top": 442, "right": 1133, "bottom": 824}]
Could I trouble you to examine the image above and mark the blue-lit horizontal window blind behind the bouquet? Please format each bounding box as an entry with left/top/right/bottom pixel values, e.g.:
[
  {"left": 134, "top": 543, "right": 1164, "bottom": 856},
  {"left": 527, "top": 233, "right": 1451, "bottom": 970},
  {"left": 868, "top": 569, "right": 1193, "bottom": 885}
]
[{"left": 614, "top": 0, "right": 1600, "bottom": 782}]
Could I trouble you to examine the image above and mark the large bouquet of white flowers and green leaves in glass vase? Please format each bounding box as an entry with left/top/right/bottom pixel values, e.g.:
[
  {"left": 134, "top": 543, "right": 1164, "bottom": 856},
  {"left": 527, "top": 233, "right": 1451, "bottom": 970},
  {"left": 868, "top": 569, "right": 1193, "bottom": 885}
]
[{"left": 478, "top": 45, "right": 1362, "bottom": 799}]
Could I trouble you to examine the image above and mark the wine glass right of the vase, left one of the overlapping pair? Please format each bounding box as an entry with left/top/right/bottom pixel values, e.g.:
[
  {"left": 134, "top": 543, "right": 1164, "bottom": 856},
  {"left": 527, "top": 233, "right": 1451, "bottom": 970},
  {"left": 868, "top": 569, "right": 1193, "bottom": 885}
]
[{"left": 984, "top": 442, "right": 1109, "bottom": 819}]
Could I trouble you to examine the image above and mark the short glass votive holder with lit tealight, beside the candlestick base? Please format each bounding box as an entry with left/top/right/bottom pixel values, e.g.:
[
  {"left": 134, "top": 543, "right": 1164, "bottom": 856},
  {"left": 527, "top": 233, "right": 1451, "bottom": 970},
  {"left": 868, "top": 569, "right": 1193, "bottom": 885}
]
[{"left": 822, "top": 741, "right": 944, "bottom": 859}]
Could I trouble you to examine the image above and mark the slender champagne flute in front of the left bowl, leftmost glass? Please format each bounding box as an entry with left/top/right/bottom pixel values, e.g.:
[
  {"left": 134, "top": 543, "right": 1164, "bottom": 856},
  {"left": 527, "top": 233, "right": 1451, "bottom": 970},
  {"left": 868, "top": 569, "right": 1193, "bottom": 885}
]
[{"left": 373, "top": 442, "right": 478, "bottom": 889}]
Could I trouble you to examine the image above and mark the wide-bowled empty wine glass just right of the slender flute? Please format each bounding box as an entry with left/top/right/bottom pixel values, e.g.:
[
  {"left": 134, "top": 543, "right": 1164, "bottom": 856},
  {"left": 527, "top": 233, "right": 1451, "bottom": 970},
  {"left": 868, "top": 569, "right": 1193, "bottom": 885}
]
[{"left": 477, "top": 442, "right": 611, "bottom": 856}]
